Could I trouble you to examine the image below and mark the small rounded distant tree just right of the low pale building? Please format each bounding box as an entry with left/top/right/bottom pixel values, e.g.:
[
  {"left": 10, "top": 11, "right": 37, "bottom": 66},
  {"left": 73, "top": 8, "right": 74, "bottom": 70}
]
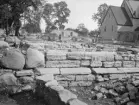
[{"left": 76, "top": 23, "right": 89, "bottom": 35}]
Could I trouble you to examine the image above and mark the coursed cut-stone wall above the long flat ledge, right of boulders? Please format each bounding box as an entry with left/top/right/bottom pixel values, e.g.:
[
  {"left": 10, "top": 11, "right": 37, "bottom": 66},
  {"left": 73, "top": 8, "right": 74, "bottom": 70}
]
[{"left": 46, "top": 52, "right": 139, "bottom": 68}]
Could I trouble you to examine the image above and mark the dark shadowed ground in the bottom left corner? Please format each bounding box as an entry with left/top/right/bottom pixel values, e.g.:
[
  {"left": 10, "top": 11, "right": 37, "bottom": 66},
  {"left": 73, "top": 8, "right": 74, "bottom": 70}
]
[{"left": 0, "top": 91, "right": 48, "bottom": 105}]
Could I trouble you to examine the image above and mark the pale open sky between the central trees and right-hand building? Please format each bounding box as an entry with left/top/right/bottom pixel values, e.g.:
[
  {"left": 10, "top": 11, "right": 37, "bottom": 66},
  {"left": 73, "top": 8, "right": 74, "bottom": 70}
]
[{"left": 45, "top": 0, "right": 123, "bottom": 30}]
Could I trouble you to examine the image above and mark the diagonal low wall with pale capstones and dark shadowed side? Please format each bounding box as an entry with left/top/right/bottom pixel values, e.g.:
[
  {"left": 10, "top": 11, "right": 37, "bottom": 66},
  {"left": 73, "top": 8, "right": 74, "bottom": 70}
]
[{"left": 36, "top": 74, "right": 87, "bottom": 105}]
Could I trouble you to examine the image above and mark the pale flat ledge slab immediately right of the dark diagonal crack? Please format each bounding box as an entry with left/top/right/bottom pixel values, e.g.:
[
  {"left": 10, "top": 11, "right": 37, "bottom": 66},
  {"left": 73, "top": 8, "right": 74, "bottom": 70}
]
[{"left": 92, "top": 68, "right": 123, "bottom": 74}]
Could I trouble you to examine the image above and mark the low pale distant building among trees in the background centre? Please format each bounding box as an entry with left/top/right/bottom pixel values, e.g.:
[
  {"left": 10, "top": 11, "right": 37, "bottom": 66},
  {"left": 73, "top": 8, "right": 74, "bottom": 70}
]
[{"left": 51, "top": 30, "right": 78, "bottom": 41}]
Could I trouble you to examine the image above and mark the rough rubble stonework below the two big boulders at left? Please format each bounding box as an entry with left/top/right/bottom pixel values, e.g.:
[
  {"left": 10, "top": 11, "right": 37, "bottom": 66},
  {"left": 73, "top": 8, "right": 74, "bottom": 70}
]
[{"left": 0, "top": 69, "right": 35, "bottom": 94}]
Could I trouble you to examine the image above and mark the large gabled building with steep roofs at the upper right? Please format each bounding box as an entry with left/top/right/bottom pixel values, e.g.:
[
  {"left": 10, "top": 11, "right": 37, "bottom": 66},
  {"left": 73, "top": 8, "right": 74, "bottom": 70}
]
[{"left": 100, "top": 0, "right": 139, "bottom": 42}]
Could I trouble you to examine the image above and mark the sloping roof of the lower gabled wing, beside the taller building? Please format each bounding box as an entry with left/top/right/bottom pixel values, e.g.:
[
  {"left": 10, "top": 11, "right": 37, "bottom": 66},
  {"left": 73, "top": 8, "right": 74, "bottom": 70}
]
[{"left": 110, "top": 6, "right": 132, "bottom": 26}]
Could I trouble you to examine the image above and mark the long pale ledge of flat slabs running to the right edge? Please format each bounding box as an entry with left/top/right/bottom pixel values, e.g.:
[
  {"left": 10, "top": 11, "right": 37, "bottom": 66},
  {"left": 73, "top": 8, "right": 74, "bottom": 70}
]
[{"left": 36, "top": 68, "right": 139, "bottom": 74}]
